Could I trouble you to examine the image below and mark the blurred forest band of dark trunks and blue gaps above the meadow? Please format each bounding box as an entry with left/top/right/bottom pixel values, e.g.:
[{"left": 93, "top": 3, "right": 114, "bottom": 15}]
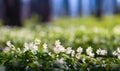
[{"left": 0, "top": 0, "right": 120, "bottom": 26}]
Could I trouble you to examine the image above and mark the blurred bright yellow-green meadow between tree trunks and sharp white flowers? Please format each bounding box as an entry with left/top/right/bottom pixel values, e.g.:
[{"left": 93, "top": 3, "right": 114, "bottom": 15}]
[{"left": 0, "top": 16, "right": 120, "bottom": 47}]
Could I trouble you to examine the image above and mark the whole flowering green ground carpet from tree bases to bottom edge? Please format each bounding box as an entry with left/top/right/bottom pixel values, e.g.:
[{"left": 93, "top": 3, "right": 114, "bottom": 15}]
[{"left": 0, "top": 16, "right": 120, "bottom": 71}]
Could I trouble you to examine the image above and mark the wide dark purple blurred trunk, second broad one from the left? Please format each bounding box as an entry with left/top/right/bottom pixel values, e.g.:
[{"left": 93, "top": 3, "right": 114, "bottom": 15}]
[{"left": 31, "top": 0, "right": 51, "bottom": 22}]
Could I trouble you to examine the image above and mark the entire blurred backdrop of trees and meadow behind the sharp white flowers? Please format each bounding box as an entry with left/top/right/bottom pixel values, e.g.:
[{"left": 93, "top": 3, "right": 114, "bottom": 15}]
[{"left": 0, "top": 0, "right": 120, "bottom": 56}]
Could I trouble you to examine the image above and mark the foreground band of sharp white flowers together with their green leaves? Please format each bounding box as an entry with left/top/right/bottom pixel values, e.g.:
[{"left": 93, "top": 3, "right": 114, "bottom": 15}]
[{"left": 0, "top": 39, "right": 120, "bottom": 71}]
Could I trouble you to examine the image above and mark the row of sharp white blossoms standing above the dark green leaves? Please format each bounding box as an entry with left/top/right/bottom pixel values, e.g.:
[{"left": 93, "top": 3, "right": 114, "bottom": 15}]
[{"left": 3, "top": 39, "right": 120, "bottom": 59}]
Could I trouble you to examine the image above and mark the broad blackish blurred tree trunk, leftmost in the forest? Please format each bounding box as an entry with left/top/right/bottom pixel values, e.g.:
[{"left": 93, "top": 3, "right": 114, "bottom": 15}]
[{"left": 3, "top": 0, "right": 22, "bottom": 26}]
